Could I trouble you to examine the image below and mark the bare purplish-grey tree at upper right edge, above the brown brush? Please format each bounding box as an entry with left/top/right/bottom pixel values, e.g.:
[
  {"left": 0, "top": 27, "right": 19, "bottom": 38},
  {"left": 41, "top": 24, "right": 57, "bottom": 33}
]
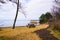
[{"left": 52, "top": 0, "right": 60, "bottom": 19}]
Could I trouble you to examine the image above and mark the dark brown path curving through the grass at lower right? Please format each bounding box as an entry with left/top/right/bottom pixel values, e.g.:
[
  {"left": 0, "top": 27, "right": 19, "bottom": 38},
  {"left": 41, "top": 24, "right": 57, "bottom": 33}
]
[{"left": 34, "top": 28, "right": 58, "bottom": 40}]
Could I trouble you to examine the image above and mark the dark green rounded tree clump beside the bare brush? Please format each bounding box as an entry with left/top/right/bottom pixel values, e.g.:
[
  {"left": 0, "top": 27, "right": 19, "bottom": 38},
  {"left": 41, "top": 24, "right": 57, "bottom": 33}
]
[{"left": 39, "top": 12, "right": 52, "bottom": 23}]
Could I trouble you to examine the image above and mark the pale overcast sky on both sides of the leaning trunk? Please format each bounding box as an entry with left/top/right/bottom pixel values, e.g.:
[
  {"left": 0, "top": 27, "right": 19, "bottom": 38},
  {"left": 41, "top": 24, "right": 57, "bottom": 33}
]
[{"left": 0, "top": 0, "right": 53, "bottom": 20}]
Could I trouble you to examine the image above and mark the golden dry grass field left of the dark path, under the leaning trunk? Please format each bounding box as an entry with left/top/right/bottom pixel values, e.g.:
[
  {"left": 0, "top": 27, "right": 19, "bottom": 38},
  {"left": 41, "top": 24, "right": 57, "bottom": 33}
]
[{"left": 0, "top": 24, "right": 48, "bottom": 40}]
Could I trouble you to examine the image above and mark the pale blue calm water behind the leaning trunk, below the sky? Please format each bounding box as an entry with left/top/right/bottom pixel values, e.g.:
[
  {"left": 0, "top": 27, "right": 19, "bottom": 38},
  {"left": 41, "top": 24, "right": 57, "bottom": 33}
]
[{"left": 0, "top": 20, "right": 30, "bottom": 27}]
